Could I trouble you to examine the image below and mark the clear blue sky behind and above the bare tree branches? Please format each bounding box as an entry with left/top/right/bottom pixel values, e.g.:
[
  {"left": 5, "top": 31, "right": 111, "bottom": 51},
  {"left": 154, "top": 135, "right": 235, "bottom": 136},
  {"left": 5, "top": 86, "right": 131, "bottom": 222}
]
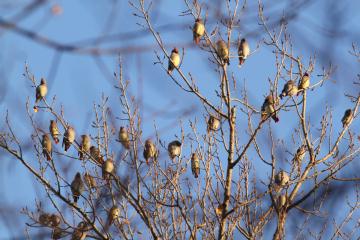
[{"left": 0, "top": 0, "right": 360, "bottom": 239}]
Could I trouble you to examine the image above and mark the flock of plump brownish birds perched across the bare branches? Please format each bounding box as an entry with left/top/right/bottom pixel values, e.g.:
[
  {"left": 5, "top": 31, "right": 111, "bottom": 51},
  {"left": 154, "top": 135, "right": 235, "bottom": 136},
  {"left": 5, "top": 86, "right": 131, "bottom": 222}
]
[{"left": 28, "top": 18, "right": 353, "bottom": 240}]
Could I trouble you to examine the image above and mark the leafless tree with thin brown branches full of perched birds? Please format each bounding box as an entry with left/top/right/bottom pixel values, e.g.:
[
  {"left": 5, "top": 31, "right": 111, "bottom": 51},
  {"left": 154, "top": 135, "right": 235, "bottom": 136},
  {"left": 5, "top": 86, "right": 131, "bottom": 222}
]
[{"left": 0, "top": 0, "right": 360, "bottom": 240}]
